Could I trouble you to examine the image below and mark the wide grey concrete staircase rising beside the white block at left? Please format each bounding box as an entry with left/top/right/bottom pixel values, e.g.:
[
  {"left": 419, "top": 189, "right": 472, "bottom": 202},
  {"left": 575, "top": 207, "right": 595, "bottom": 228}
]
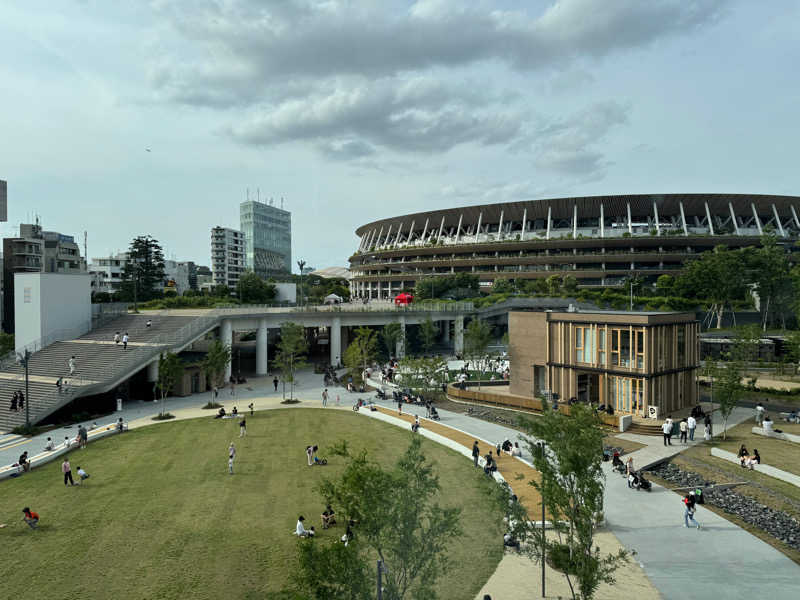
[{"left": 0, "top": 315, "right": 218, "bottom": 432}]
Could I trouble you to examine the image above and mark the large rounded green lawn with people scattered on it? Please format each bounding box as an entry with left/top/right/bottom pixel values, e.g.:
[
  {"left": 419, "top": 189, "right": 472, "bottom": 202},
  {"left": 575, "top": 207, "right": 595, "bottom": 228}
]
[{"left": 0, "top": 409, "right": 503, "bottom": 600}]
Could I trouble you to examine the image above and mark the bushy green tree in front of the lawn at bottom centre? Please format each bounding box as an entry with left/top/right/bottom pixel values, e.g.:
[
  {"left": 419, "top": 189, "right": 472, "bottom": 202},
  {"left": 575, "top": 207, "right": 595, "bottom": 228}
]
[{"left": 317, "top": 436, "right": 461, "bottom": 600}]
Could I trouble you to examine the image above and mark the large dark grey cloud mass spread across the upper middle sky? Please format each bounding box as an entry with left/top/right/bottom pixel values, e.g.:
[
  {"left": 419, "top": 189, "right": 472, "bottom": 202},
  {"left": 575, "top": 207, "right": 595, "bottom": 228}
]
[{"left": 148, "top": 0, "right": 726, "bottom": 166}]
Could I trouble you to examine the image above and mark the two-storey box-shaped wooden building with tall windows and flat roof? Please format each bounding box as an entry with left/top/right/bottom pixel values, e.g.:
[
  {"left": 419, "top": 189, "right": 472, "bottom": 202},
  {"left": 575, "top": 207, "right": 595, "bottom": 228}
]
[{"left": 508, "top": 311, "right": 700, "bottom": 418}]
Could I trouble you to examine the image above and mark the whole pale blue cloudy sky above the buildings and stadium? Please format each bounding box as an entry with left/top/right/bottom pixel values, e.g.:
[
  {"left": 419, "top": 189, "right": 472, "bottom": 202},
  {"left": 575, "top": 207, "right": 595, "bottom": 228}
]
[{"left": 0, "top": 0, "right": 800, "bottom": 268}]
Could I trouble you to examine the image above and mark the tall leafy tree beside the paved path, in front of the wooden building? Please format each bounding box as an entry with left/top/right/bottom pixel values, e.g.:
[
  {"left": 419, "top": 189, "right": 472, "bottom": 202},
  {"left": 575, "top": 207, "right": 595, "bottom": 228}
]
[{"left": 513, "top": 404, "right": 627, "bottom": 600}]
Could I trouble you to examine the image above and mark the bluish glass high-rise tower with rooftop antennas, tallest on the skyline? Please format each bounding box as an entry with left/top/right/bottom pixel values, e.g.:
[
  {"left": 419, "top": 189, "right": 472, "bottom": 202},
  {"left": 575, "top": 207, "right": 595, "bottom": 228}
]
[{"left": 239, "top": 200, "right": 292, "bottom": 277}]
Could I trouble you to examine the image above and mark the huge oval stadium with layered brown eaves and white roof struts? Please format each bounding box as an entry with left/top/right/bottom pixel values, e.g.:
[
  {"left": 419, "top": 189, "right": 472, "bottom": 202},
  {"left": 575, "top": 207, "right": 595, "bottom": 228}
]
[{"left": 350, "top": 194, "right": 800, "bottom": 299}]
